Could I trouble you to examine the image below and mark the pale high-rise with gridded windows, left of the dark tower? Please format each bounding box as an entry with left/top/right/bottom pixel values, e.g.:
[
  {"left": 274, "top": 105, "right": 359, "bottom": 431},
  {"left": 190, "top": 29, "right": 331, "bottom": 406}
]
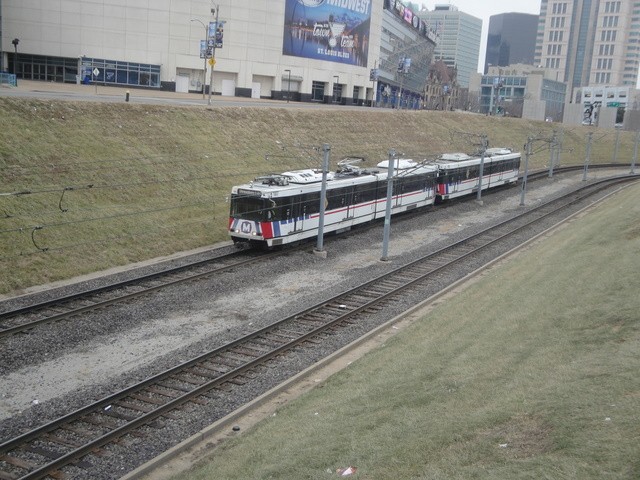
[{"left": 418, "top": 4, "right": 482, "bottom": 88}]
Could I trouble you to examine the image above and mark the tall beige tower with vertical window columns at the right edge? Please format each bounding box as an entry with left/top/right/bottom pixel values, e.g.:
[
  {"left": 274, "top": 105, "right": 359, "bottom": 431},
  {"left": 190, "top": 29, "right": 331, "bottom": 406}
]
[{"left": 534, "top": 0, "right": 640, "bottom": 91}]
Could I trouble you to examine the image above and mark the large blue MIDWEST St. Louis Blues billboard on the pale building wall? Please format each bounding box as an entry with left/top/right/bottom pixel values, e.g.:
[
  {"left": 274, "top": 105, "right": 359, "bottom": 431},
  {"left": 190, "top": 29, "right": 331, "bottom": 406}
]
[{"left": 282, "top": 0, "right": 372, "bottom": 67}]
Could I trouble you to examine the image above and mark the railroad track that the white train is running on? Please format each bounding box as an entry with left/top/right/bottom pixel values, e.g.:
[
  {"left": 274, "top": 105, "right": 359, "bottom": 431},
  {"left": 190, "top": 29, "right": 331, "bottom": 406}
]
[{"left": 0, "top": 164, "right": 627, "bottom": 339}]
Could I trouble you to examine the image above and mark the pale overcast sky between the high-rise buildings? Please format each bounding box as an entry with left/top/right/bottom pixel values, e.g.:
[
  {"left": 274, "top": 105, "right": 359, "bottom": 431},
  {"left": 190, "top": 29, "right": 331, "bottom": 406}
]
[{"left": 420, "top": 0, "right": 540, "bottom": 72}]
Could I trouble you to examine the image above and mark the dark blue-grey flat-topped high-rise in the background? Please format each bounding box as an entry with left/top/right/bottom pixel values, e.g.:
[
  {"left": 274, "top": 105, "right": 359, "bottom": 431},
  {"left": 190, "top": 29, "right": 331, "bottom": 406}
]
[{"left": 484, "top": 12, "right": 538, "bottom": 73}]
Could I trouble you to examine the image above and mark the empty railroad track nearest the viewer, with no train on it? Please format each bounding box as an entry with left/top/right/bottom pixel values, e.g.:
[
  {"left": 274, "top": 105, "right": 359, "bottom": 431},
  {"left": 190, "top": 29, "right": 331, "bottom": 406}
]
[{"left": 0, "top": 175, "right": 640, "bottom": 479}]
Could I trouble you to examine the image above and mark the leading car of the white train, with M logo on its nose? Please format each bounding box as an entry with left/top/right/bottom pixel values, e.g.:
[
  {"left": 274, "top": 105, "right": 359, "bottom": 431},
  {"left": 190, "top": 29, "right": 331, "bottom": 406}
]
[{"left": 229, "top": 159, "right": 437, "bottom": 247}]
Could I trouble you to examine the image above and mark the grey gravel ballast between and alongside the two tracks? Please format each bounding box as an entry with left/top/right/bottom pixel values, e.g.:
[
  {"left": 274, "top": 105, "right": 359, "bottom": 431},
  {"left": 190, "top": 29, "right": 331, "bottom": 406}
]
[{"left": 0, "top": 172, "right": 619, "bottom": 478}]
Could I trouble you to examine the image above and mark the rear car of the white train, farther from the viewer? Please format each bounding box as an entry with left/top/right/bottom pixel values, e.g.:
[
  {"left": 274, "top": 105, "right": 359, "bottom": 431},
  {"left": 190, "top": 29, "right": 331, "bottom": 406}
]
[{"left": 436, "top": 148, "right": 521, "bottom": 200}]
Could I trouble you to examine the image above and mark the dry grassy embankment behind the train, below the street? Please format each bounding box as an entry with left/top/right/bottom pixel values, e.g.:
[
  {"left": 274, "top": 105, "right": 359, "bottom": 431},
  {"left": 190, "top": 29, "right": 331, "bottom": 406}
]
[{"left": 0, "top": 98, "right": 634, "bottom": 294}]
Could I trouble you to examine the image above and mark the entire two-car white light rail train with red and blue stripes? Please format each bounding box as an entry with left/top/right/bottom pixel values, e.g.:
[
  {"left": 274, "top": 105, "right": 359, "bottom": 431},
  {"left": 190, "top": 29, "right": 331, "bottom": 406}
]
[{"left": 229, "top": 148, "right": 521, "bottom": 247}]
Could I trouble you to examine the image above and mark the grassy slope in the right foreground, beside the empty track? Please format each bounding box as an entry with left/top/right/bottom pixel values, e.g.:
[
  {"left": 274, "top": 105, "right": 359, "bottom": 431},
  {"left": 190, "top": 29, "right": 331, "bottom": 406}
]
[{"left": 176, "top": 186, "right": 640, "bottom": 480}]
